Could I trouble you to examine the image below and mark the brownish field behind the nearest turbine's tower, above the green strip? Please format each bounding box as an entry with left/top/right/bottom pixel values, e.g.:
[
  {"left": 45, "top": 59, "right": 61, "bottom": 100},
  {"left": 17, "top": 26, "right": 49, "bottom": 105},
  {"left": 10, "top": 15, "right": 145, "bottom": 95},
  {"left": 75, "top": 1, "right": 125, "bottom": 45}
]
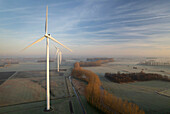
[{"left": 0, "top": 71, "right": 68, "bottom": 106}]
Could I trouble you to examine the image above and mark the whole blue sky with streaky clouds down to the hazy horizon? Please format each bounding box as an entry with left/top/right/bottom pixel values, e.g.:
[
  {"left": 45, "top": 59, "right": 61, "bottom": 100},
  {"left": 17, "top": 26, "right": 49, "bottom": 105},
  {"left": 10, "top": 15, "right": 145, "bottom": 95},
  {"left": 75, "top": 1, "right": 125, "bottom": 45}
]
[{"left": 0, "top": 0, "right": 170, "bottom": 57}]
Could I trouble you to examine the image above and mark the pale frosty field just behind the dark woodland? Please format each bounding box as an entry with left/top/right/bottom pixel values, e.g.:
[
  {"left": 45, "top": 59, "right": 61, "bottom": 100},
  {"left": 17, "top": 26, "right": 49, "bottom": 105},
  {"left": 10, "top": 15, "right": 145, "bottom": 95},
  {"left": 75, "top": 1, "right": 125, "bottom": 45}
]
[{"left": 84, "top": 60, "right": 170, "bottom": 77}]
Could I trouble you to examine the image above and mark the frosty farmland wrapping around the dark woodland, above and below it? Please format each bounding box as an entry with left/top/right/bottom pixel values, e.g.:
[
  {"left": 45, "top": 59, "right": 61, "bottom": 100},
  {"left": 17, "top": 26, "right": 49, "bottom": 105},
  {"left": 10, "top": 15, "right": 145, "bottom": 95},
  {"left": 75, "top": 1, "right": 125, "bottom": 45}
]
[{"left": 83, "top": 62, "right": 170, "bottom": 114}]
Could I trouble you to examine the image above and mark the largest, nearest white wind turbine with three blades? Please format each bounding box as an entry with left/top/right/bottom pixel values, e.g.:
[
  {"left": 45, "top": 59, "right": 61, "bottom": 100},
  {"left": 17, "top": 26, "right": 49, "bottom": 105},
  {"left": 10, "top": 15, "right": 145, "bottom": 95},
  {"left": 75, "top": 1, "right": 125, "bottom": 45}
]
[{"left": 23, "top": 6, "right": 72, "bottom": 111}]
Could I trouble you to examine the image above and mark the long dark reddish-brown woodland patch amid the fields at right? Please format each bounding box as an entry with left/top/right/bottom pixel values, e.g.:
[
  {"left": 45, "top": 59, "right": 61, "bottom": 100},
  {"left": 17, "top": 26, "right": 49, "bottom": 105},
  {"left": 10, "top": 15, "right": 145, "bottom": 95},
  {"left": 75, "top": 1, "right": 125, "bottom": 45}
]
[{"left": 105, "top": 72, "right": 170, "bottom": 83}]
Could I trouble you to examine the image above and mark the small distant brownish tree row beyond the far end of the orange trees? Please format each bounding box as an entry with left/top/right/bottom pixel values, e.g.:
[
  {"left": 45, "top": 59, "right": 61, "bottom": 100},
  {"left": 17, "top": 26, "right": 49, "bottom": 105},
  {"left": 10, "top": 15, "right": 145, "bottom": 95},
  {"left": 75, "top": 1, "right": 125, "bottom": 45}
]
[{"left": 79, "top": 58, "right": 113, "bottom": 67}]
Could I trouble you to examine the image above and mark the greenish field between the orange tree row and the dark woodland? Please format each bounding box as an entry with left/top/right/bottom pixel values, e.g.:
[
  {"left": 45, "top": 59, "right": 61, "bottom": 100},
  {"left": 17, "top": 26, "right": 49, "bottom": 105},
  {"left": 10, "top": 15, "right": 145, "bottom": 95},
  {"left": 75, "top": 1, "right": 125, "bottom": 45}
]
[{"left": 101, "top": 78, "right": 170, "bottom": 114}]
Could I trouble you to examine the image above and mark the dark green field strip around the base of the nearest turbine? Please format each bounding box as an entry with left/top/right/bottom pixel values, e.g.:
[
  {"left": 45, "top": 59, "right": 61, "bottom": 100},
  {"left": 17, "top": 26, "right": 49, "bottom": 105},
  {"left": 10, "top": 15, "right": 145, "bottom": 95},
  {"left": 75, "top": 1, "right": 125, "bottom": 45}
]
[{"left": 0, "top": 98, "right": 70, "bottom": 114}]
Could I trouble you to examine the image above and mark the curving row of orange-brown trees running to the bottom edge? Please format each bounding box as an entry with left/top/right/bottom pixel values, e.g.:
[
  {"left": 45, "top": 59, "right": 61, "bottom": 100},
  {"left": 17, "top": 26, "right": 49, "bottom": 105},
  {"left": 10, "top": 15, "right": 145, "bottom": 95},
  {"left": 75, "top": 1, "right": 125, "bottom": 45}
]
[{"left": 72, "top": 62, "right": 145, "bottom": 114}]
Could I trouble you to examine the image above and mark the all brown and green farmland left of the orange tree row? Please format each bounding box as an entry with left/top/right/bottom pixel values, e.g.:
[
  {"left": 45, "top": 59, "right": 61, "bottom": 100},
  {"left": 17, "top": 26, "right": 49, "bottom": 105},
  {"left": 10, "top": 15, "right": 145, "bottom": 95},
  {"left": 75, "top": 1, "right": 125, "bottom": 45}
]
[{"left": 0, "top": 61, "right": 99, "bottom": 114}]
